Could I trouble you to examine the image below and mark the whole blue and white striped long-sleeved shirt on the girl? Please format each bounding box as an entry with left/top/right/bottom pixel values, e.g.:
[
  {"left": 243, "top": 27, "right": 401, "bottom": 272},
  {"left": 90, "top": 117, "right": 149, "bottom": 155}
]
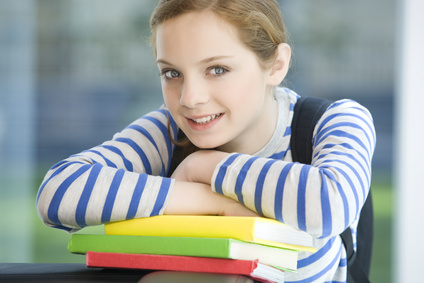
[{"left": 37, "top": 88, "right": 376, "bottom": 282}]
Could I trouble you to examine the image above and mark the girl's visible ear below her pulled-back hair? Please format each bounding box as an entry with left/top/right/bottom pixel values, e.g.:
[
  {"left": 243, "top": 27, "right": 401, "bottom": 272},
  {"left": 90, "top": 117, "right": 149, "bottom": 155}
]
[{"left": 268, "top": 43, "right": 291, "bottom": 86}]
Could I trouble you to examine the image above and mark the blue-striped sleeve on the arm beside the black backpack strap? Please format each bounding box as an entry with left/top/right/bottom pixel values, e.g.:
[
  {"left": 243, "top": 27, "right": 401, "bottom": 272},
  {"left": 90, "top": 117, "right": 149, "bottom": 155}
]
[{"left": 212, "top": 100, "right": 376, "bottom": 241}]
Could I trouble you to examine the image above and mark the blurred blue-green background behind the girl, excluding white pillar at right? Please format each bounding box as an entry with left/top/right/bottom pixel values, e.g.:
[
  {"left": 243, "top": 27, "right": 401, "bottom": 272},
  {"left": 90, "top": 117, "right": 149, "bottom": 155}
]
[{"left": 0, "top": 0, "right": 397, "bottom": 283}]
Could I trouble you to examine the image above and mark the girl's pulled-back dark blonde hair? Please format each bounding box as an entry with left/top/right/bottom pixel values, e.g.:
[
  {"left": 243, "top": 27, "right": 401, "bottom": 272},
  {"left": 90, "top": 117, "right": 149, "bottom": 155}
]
[{"left": 150, "top": 0, "right": 288, "bottom": 68}]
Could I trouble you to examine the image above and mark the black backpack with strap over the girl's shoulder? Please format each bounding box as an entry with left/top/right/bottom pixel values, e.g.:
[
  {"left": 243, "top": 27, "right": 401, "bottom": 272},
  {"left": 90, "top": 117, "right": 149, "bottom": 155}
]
[{"left": 290, "top": 97, "right": 373, "bottom": 283}]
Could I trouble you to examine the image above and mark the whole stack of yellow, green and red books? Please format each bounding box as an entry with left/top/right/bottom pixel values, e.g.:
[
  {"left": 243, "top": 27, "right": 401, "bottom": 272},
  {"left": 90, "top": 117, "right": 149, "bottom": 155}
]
[{"left": 68, "top": 215, "right": 315, "bottom": 282}]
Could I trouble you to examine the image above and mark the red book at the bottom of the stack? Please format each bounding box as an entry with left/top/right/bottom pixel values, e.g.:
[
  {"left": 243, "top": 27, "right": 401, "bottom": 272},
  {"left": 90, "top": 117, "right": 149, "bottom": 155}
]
[{"left": 86, "top": 251, "right": 284, "bottom": 282}]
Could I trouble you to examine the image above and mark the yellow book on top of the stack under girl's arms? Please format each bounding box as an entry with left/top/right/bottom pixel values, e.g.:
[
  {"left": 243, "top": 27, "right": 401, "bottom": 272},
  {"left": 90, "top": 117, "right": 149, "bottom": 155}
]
[{"left": 105, "top": 215, "right": 316, "bottom": 252}]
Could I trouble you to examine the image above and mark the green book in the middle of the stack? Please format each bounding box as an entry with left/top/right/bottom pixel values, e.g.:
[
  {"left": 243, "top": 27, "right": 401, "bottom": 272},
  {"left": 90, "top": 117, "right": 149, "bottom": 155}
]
[{"left": 68, "top": 234, "right": 298, "bottom": 271}]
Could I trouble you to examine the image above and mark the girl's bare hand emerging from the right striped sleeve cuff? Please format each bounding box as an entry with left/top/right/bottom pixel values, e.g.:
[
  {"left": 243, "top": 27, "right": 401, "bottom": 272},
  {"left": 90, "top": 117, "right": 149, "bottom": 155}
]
[{"left": 171, "top": 150, "right": 229, "bottom": 185}]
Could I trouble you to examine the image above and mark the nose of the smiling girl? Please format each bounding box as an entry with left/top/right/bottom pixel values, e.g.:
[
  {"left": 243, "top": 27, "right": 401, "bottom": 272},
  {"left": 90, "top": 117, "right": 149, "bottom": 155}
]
[{"left": 180, "top": 77, "right": 210, "bottom": 108}]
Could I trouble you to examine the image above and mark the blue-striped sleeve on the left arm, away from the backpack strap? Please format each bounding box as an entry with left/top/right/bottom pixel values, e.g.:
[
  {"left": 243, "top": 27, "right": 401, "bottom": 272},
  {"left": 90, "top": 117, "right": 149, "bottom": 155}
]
[{"left": 37, "top": 109, "right": 177, "bottom": 231}]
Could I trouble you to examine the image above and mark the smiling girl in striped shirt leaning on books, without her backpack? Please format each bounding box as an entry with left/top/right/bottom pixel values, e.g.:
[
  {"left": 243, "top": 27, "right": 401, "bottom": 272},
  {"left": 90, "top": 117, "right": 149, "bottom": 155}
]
[{"left": 37, "top": 0, "right": 375, "bottom": 282}]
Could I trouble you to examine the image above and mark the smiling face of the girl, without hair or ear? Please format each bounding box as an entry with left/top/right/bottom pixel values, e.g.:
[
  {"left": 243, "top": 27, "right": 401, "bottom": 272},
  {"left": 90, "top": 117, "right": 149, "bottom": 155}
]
[{"left": 156, "top": 12, "right": 277, "bottom": 154}]
